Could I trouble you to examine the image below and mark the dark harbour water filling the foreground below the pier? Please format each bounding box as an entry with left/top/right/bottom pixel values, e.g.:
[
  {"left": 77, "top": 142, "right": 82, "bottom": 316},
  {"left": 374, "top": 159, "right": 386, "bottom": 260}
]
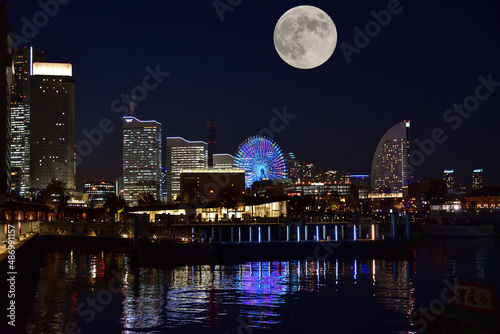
[{"left": 0, "top": 237, "right": 500, "bottom": 334}]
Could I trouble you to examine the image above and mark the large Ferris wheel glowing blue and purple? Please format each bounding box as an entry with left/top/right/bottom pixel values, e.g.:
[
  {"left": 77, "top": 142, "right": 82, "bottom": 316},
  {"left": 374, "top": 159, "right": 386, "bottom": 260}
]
[{"left": 234, "top": 136, "right": 286, "bottom": 188}]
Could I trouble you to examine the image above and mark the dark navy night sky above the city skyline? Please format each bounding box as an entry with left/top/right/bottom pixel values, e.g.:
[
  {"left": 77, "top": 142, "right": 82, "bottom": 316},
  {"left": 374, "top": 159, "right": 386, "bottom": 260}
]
[{"left": 8, "top": 0, "right": 500, "bottom": 188}]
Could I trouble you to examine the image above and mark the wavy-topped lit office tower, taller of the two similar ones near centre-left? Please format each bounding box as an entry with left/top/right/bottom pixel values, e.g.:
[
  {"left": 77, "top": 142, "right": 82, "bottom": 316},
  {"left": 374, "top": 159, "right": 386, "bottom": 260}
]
[{"left": 123, "top": 116, "right": 162, "bottom": 205}]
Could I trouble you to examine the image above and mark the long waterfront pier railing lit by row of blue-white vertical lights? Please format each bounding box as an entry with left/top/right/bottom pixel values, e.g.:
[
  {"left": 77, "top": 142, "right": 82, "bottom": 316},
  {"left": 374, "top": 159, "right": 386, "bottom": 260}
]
[{"left": 31, "top": 217, "right": 394, "bottom": 243}]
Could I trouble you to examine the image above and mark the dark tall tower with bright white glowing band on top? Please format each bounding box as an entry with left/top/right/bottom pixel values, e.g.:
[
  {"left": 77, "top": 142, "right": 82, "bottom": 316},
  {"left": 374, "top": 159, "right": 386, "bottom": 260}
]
[{"left": 30, "top": 63, "right": 76, "bottom": 191}]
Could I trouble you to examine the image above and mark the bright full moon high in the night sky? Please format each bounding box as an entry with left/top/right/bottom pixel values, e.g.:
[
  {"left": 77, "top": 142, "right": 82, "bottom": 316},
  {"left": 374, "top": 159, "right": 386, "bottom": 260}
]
[{"left": 274, "top": 6, "right": 337, "bottom": 69}]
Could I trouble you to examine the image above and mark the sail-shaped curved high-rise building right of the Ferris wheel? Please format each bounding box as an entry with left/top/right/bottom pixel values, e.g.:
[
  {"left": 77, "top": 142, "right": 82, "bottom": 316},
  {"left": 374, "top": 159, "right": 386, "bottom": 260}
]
[{"left": 371, "top": 121, "right": 411, "bottom": 193}]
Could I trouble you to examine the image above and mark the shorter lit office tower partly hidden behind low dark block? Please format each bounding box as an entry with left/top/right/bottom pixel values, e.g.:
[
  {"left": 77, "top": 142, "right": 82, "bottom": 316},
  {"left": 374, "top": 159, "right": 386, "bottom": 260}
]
[{"left": 167, "top": 137, "right": 208, "bottom": 202}]
